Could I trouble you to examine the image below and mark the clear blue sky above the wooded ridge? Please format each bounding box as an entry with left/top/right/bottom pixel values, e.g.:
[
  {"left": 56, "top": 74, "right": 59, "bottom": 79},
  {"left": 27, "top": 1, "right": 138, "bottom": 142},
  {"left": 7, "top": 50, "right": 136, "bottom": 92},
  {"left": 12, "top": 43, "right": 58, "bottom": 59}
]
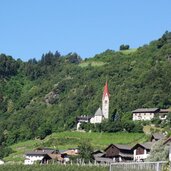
[{"left": 0, "top": 0, "right": 171, "bottom": 61}]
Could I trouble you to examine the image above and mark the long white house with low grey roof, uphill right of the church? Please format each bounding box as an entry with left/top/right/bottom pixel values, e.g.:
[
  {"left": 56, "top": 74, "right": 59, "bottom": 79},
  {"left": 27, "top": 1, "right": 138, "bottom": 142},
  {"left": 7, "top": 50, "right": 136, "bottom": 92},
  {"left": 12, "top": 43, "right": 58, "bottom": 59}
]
[{"left": 132, "top": 108, "right": 160, "bottom": 121}]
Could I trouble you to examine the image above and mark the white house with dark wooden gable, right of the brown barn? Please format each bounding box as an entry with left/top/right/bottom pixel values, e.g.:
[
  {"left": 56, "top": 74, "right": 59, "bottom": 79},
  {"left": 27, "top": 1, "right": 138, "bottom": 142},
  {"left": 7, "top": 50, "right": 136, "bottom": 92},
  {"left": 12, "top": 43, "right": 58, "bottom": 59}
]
[{"left": 132, "top": 142, "right": 154, "bottom": 161}]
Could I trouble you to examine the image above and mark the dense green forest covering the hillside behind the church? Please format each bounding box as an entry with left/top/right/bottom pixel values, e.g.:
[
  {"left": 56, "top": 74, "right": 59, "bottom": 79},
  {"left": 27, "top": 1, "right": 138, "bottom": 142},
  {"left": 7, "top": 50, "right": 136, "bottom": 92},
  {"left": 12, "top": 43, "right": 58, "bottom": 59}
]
[{"left": 0, "top": 32, "right": 171, "bottom": 145}]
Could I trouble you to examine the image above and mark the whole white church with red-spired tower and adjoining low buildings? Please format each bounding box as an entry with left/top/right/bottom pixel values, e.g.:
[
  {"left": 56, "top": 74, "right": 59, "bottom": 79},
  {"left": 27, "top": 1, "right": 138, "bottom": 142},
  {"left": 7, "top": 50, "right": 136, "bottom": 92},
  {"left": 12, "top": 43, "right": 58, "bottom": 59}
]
[{"left": 77, "top": 81, "right": 109, "bottom": 130}]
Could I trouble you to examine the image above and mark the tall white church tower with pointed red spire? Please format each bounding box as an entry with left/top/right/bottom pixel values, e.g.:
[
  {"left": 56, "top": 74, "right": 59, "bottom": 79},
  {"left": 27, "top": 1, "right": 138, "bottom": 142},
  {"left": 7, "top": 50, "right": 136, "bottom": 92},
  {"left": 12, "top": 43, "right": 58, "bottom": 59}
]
[{"left": 102, "top": 81, "right": 109, "bottom": 119}]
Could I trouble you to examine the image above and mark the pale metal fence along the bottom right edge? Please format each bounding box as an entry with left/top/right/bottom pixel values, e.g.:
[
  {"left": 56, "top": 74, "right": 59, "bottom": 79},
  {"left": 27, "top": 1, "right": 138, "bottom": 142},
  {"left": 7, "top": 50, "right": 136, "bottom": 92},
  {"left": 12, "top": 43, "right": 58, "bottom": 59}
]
[{"left": 109, "top": 161, "right": 171, "bottom": 171}]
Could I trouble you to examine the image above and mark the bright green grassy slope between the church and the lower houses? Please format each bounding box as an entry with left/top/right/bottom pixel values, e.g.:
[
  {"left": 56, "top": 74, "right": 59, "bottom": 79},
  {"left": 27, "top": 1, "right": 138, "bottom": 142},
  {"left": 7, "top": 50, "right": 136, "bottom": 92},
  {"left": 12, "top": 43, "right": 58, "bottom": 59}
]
[{"left": 4, "top": 131, "right": 147, "bottom": 162}]
